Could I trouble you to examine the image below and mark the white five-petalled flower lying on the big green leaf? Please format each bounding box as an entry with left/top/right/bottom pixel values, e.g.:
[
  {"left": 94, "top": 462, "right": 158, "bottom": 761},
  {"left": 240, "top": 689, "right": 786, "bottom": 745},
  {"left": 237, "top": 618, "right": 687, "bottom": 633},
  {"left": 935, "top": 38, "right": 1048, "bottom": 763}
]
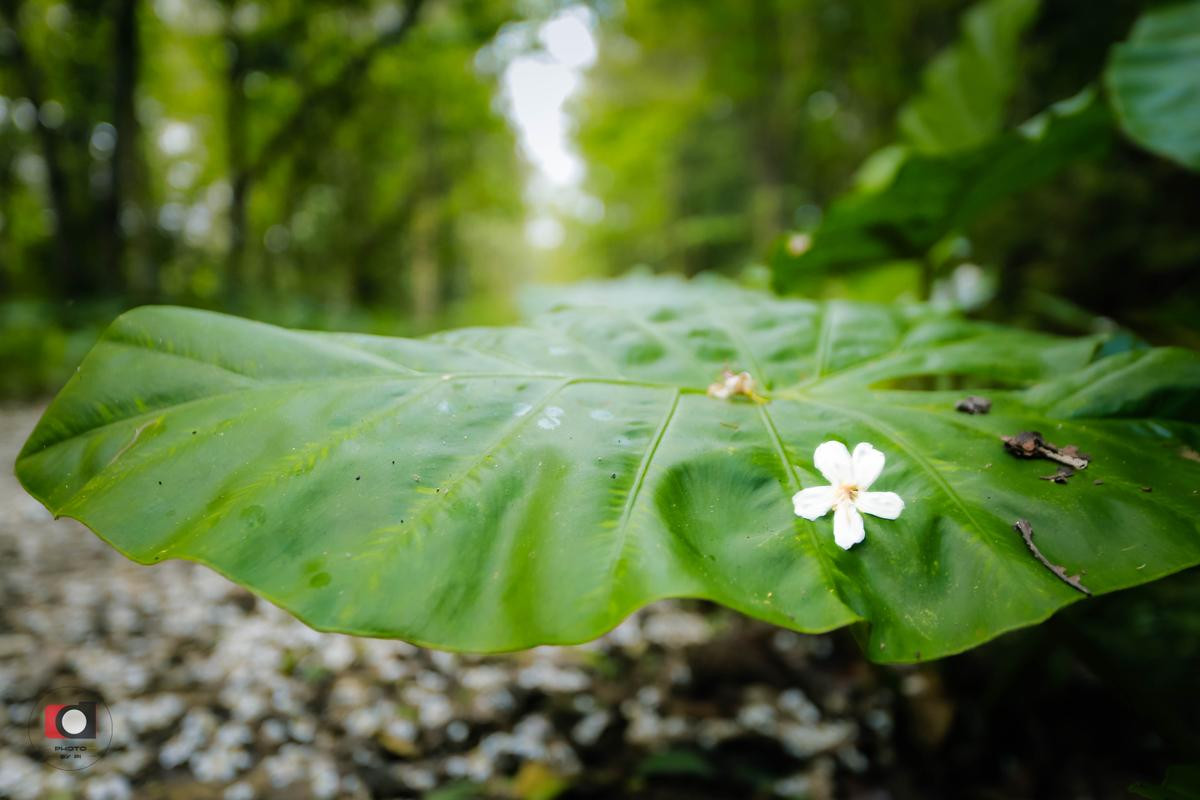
[{"left": 792, "top": 441, "right": 904, "bottom": 551}]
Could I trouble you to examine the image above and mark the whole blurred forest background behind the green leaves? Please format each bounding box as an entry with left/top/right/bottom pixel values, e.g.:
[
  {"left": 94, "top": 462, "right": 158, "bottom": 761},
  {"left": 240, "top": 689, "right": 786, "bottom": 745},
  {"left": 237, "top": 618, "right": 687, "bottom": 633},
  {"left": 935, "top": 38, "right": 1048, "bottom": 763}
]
[{"left": 0, "top": 0, "right": 1200, "bottom": 396}]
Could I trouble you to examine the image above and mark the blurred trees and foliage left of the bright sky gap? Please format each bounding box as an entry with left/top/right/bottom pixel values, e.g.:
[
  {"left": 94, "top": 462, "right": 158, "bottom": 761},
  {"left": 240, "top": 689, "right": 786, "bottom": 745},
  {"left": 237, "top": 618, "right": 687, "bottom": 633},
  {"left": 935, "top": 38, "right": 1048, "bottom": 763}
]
[{"left": 0, "top": 0, "right": 535, "bottom": 395}]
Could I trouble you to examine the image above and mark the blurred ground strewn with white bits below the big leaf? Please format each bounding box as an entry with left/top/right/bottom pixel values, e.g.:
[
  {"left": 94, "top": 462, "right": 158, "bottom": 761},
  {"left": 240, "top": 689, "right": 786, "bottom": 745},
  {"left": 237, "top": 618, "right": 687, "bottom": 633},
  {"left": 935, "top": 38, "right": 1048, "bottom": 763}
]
[{"left": 0, "top": 407, "right": 907, "bottom": 800}]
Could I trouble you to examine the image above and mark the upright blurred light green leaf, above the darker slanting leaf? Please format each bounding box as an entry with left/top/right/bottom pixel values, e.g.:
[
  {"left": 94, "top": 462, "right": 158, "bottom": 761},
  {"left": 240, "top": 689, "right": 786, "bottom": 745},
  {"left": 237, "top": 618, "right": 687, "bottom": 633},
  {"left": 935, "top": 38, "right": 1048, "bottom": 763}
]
[{"left": 899, "top": 0, "right": 1038, "bottom": 155}]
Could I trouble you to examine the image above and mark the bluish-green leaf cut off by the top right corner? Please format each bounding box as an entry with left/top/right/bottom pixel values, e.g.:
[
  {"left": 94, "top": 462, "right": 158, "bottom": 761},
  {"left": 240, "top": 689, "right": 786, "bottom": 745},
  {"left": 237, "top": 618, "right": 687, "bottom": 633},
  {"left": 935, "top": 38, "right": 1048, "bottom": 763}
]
[{"left": 1104, "top": 0, "right": 1200, "bottom": 169}]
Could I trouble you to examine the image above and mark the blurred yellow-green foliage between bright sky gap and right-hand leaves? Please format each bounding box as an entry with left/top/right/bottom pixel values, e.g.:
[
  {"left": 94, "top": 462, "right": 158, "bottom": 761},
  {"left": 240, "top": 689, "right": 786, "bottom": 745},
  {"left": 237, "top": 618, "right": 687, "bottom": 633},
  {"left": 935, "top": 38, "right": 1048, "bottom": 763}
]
[{"left": 560, "top": 0, "right": 962, "bottom": 275}]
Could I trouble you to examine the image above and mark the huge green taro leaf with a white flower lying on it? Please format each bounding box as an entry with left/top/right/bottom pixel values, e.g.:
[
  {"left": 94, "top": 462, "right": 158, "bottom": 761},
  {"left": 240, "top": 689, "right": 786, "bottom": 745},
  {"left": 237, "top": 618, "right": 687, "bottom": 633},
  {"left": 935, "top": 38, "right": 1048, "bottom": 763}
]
[{"left": 17, "top": 281, "right": 1200, "bottom": 661}]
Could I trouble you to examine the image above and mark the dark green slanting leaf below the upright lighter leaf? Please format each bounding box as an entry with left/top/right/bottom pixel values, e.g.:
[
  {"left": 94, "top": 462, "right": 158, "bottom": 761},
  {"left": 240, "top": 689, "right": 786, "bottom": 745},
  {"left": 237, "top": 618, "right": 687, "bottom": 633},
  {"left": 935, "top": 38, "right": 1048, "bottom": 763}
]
[{"left": 772, "top": 89, "right": 1110, "bottom": 291}]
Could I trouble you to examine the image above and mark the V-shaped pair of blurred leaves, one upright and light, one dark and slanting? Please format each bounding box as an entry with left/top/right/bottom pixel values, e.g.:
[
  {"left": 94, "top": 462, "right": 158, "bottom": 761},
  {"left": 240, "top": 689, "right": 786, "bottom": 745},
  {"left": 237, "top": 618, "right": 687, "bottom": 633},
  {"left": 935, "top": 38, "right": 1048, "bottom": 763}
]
[{"left": 772, "top": 0, "right": 1060, "bottom": 297}]
